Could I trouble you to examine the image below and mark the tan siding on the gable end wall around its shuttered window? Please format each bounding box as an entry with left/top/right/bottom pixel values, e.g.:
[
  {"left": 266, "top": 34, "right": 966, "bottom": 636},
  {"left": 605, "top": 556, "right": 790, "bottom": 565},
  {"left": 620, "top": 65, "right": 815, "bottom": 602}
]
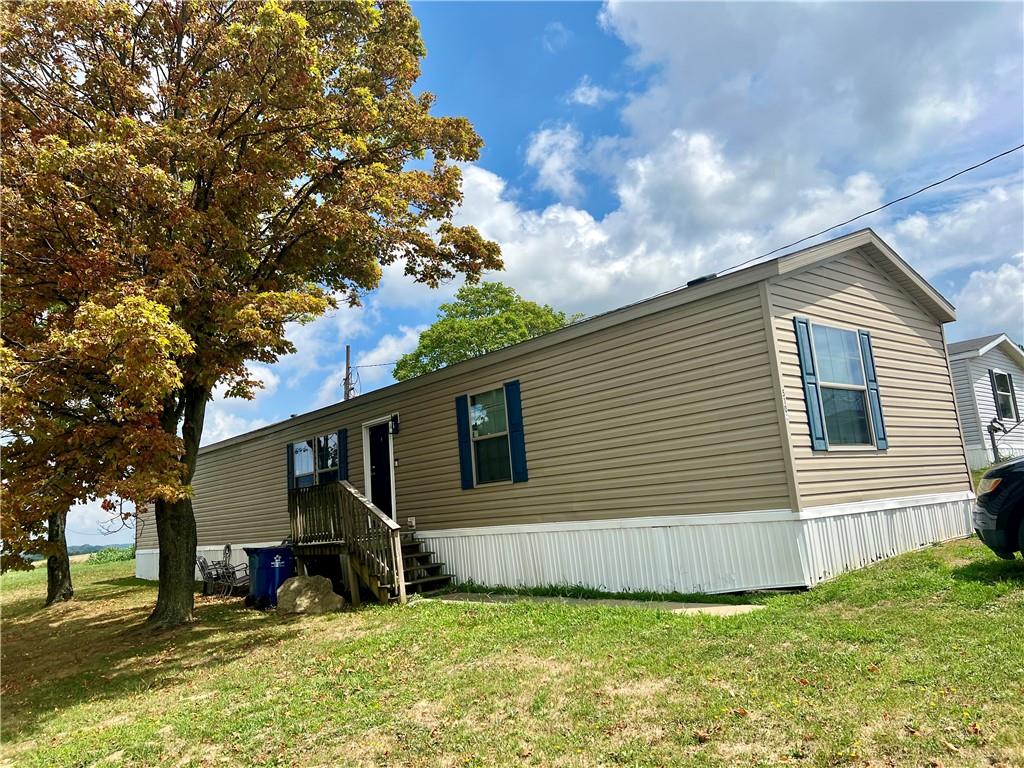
[{"left": 769, "top": 252, "right": 971, "bottom": 507}]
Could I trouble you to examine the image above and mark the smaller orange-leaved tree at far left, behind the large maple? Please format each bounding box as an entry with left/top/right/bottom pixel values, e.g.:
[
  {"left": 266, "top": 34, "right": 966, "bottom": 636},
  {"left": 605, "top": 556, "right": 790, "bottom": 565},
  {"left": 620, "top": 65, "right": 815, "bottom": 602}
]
[{"left": 0, "top": 301, "right": 190, "bottom": 605}]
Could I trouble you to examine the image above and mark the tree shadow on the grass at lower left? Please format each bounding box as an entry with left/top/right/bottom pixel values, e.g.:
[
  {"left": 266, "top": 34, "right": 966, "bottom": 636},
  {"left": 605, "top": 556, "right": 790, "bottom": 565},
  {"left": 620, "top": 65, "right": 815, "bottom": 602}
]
[{"left": 0, "top": 579, "right": 289, "bottom": 741}]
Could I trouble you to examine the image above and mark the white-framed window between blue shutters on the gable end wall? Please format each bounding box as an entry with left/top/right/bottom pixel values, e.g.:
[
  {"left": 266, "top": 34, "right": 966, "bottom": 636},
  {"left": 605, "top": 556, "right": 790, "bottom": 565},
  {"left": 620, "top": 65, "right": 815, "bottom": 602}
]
[{"left": 811, "top": 325, "right": 873, "bottom": 445}]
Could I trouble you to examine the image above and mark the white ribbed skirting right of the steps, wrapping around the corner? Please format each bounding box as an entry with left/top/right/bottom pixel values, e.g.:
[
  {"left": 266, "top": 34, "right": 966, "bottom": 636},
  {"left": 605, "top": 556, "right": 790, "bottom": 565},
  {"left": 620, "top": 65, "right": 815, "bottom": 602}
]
[{"left": 418, "top": 492, "right": 973, "bottom": 593}]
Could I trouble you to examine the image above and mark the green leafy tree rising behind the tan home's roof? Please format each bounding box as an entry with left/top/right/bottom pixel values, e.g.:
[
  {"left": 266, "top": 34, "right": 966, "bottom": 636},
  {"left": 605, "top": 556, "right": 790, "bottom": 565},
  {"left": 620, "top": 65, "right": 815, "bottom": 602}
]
[{"left": 394, "top": 282, "right": 583, "bottom": 381}]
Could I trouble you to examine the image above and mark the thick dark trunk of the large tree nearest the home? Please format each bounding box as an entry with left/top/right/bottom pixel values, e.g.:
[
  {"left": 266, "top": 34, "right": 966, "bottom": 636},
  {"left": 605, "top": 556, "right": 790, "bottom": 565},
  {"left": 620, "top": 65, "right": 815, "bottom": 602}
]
[{"left": 148, "top": 385, "right": 209, "bottom": 627}]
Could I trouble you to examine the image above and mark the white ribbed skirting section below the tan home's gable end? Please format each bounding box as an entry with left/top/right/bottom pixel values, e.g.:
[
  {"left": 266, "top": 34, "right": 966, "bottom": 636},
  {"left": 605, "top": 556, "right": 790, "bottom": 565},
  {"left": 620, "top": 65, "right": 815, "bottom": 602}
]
[{"left": 801, "top": 493, "right": 974, "bottom": 587}]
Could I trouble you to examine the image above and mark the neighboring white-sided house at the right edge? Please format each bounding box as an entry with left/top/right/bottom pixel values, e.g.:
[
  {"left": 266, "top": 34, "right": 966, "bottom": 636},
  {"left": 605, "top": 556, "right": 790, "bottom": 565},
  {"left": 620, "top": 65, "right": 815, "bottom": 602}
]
[{"left": 949, "top": 334, "right": 1024, "bottom": 469}]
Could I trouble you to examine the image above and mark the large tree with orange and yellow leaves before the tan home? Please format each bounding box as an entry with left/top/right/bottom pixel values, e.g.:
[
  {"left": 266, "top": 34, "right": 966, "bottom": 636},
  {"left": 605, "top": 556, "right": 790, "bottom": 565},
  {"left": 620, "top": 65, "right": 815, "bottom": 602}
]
[{"left": 0, "top": 0, "right": 501, "bottom": 626}]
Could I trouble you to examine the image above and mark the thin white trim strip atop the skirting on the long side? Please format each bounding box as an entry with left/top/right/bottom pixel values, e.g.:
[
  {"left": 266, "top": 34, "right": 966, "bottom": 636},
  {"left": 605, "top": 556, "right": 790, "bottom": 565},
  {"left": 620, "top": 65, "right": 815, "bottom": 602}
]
[{"left": 416, "top": 509, "right": 799, "bottom": 539}]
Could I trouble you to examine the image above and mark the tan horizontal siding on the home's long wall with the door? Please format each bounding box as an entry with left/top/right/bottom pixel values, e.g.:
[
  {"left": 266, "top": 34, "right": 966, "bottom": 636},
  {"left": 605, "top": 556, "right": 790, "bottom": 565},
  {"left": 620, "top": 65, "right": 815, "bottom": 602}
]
[{"left": 139, "top": 284, "right": 791, "bottom": 547}]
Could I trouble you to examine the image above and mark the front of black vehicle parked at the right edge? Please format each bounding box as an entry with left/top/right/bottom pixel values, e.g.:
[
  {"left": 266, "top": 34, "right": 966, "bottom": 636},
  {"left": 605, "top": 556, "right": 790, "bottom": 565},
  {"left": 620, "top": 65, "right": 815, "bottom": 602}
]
[{"left": 974, "top": 458, "right": 1024, "bottom": 560}]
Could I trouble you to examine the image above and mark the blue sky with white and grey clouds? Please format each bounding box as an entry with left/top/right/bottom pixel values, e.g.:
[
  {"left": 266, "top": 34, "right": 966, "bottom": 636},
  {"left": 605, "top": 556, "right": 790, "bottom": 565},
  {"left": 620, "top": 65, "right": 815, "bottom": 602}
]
[{"left": 69, "top": 2, "right": 1024, "bottom": 543}]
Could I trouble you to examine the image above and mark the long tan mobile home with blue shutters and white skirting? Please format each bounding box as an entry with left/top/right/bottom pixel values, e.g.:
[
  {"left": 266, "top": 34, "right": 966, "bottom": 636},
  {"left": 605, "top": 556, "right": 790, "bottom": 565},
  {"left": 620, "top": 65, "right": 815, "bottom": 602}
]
[{"left": 136, "top": 229, "right": 973, "bottom": 597}]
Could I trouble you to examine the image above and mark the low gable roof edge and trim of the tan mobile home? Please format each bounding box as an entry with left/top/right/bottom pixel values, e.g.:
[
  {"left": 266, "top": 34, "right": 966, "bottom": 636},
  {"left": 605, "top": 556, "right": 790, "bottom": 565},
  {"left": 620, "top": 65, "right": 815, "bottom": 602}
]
[{"left": 200, "top": 228, "right": 956, "bottom": 453}]
